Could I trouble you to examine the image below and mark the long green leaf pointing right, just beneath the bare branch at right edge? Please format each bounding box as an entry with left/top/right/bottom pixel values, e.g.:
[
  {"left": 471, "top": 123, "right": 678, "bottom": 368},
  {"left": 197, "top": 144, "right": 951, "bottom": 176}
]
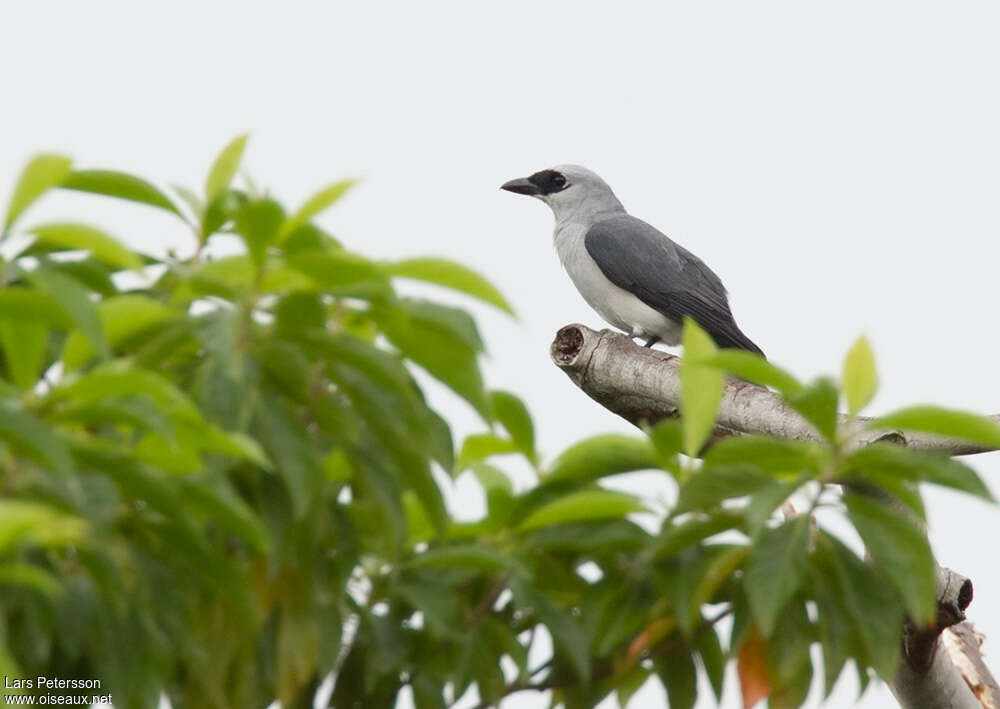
[{"left": 839, "top": 443, "right": 995, "bottom": 502}]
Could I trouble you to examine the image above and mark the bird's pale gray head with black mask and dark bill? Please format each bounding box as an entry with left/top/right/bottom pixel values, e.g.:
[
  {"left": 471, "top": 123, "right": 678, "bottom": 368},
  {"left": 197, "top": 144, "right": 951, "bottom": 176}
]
[{"left": 500, "top": 165, "right": 622, "bottom": 218}]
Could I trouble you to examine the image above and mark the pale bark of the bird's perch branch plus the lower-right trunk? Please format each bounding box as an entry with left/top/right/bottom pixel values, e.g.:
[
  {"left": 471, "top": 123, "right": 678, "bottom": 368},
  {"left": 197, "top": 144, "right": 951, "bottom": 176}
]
[{"left": 551, "top": 324, "right": 1000, "bottom": 709}]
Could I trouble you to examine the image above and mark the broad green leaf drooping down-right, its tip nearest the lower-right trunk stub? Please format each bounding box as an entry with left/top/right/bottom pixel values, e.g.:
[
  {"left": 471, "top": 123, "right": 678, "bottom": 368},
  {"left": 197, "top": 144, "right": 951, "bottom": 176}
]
[{"left": 844, "top": 494, "right": 936, "bottom": 623}]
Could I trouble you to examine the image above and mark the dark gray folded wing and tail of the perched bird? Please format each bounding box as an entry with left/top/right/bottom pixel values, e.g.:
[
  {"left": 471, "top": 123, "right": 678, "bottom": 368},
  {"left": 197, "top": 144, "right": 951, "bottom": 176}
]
[{"left": 584, "top": 214, "right": 763, "bottom": 354}]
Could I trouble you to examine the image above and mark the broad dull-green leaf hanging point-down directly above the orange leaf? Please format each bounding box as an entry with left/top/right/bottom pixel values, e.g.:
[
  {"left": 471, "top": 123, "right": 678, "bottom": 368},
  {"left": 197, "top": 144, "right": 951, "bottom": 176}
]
[{"left": 744, "top": 515, "right": 809, "bottom": 637}]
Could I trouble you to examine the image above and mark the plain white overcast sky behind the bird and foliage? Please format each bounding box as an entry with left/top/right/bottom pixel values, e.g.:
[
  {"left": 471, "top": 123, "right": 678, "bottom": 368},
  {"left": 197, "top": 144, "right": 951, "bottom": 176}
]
[{"left": 0, "top": 0, "right": 1000, "bottom": 709}]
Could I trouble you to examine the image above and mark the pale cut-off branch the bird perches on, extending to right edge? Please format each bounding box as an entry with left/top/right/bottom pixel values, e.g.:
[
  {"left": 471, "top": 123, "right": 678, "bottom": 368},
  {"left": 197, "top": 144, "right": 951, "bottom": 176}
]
[{"left": 550, "top": 324, "right": 1000, "bottom": 455}]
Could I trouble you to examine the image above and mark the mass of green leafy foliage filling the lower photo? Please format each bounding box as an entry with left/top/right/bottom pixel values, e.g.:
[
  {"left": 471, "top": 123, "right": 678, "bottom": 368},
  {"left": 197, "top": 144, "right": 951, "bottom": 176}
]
[{"left": 0, "top": 144, "right": 1000, "bottom": 708}]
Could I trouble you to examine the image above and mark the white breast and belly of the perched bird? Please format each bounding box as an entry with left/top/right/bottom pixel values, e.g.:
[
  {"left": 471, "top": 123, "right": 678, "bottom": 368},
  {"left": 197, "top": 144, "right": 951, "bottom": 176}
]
[{"left": 555, "top": 224, "right": 681, "bottom": 345}]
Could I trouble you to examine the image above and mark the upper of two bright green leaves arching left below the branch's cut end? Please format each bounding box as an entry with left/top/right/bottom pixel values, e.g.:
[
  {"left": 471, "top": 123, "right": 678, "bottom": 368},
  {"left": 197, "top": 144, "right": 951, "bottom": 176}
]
[{"left": 545, "top": 433, "right": 658, "bottom": 482}]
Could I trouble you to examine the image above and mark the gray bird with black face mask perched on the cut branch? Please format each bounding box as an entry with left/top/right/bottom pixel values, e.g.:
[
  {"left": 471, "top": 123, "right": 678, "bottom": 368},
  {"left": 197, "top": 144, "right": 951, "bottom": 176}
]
[{"left": 501, "top": 165, "right": 764, "bottom": 355}]
